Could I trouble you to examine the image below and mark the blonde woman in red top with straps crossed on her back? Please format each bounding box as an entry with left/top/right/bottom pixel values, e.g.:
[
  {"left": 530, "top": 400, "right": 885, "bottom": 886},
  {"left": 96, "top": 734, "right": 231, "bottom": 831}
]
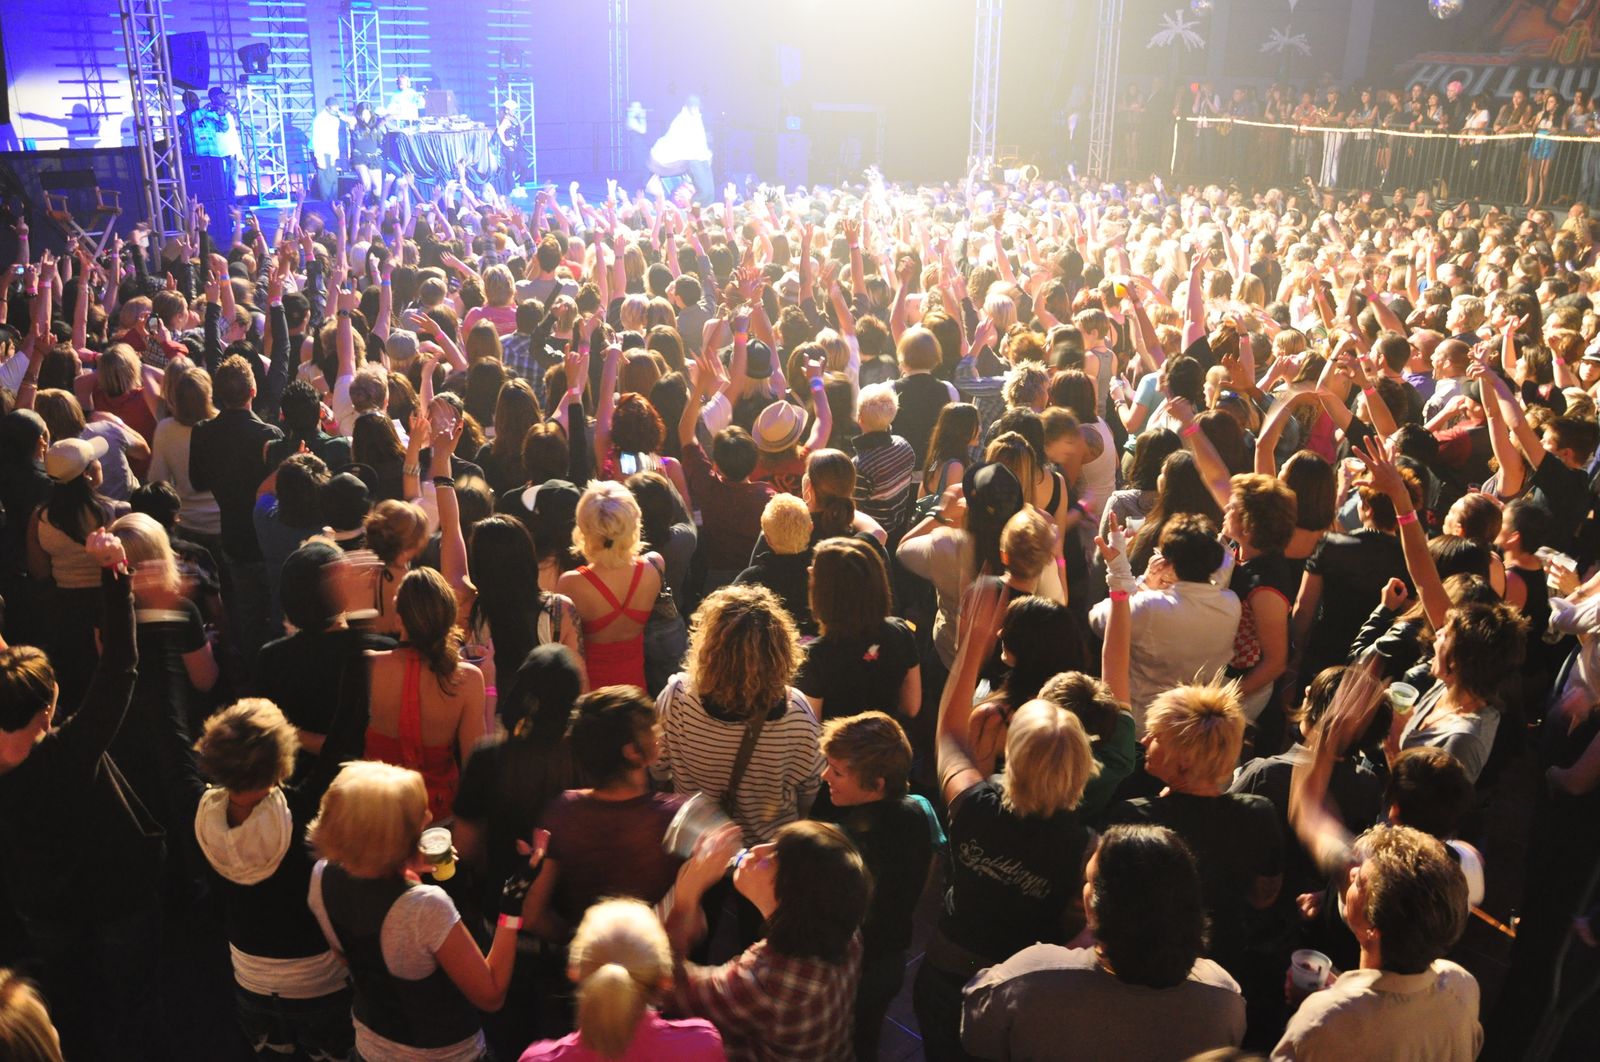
[{"left": 555, "top": 480, "right": 662, "bottom": 689}]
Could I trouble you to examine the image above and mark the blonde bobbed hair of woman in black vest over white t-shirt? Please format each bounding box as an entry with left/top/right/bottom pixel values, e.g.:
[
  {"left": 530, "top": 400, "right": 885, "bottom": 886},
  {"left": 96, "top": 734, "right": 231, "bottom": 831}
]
[{"left": 306, "top": 760, "right": 427, "bottom": 878}]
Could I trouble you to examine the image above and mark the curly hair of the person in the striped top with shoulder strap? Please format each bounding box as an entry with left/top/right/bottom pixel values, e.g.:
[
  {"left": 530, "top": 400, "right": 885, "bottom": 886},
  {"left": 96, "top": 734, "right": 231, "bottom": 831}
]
[{"left": 683, "top": 584, "right": 805, "bottom": 715}]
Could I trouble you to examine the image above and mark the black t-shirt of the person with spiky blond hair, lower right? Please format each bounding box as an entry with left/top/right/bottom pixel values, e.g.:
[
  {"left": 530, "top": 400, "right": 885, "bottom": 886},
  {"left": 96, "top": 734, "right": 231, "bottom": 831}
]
[{"left": 1109, "top": 793, "right": 1283, "bottom": 977}]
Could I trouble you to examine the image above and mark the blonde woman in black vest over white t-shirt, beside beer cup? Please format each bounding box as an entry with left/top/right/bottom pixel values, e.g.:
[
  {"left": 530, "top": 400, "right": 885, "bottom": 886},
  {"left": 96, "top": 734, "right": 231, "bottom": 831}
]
[{"left": 306, "top": 760, "right": 544, "bottom": 1062}]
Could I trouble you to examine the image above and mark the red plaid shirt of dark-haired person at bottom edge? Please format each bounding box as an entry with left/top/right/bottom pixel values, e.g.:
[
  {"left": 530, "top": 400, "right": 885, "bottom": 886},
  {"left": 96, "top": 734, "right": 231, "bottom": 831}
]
[{"left": 669, "top": 932, "right": 861, "bottom": 1062}]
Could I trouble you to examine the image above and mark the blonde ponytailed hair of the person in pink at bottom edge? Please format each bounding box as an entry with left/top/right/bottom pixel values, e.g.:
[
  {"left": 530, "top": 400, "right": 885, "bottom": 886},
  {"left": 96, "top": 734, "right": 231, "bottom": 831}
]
[{"left": 566, "top": 899, "right": 672, "bottom": 1059}]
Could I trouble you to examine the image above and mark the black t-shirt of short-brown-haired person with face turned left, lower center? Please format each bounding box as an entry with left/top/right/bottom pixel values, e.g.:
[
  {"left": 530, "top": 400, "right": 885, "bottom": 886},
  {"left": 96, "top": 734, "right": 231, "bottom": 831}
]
[{"left": 819, "top": 793, "right": 944, "bottom": 956}]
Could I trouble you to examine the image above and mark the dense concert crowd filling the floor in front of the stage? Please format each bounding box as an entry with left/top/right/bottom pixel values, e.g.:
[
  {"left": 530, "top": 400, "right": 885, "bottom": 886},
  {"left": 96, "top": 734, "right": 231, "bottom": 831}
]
[{"left": 0, "top": 155, "right": 1600, "bottom": 1062}]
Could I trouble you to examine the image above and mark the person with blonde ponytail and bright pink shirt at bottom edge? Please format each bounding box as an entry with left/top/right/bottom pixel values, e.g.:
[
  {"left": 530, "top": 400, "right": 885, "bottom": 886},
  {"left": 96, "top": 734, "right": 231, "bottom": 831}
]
[{"left": 518, "top": 899, "right": 726, "bottom": 1062}]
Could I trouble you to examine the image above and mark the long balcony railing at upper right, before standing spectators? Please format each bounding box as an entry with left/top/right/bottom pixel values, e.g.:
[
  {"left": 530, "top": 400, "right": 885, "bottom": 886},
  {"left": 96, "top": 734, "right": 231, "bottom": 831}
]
[{"left": 1170, "top": 118, "right": 1600, "bottom": 206}]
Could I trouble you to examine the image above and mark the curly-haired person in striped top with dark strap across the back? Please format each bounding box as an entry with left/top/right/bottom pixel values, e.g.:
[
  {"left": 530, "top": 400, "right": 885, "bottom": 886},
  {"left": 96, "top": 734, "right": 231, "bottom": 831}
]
[{"left": 651, "top": 584, "right": 822, "bottom": 841}]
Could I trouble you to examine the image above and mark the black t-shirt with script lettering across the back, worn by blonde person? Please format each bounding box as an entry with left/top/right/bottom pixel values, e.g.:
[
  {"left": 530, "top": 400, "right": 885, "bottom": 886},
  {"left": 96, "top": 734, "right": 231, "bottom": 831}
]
[{"left": 939, "top": 779, "right": 1091, "bottom": 963}]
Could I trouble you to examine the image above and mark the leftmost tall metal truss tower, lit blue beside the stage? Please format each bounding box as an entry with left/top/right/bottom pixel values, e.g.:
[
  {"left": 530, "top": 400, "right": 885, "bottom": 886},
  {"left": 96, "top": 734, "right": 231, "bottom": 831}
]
[{"left": 118, "top": 0, "right": 189, "bottom": 242}]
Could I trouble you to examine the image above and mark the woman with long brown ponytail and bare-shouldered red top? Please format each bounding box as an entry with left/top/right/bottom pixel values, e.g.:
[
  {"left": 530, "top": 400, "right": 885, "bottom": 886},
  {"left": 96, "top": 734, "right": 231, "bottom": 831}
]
[{"left": 366, "top": 568, "right": 488, "bottom": 822}]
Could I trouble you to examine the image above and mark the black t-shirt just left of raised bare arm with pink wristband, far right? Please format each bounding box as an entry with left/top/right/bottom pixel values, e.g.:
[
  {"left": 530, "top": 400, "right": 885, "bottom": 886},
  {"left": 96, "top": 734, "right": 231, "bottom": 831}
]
[{"left": 1301, "top": 528, "right": 1411, "bottom": 677}]
